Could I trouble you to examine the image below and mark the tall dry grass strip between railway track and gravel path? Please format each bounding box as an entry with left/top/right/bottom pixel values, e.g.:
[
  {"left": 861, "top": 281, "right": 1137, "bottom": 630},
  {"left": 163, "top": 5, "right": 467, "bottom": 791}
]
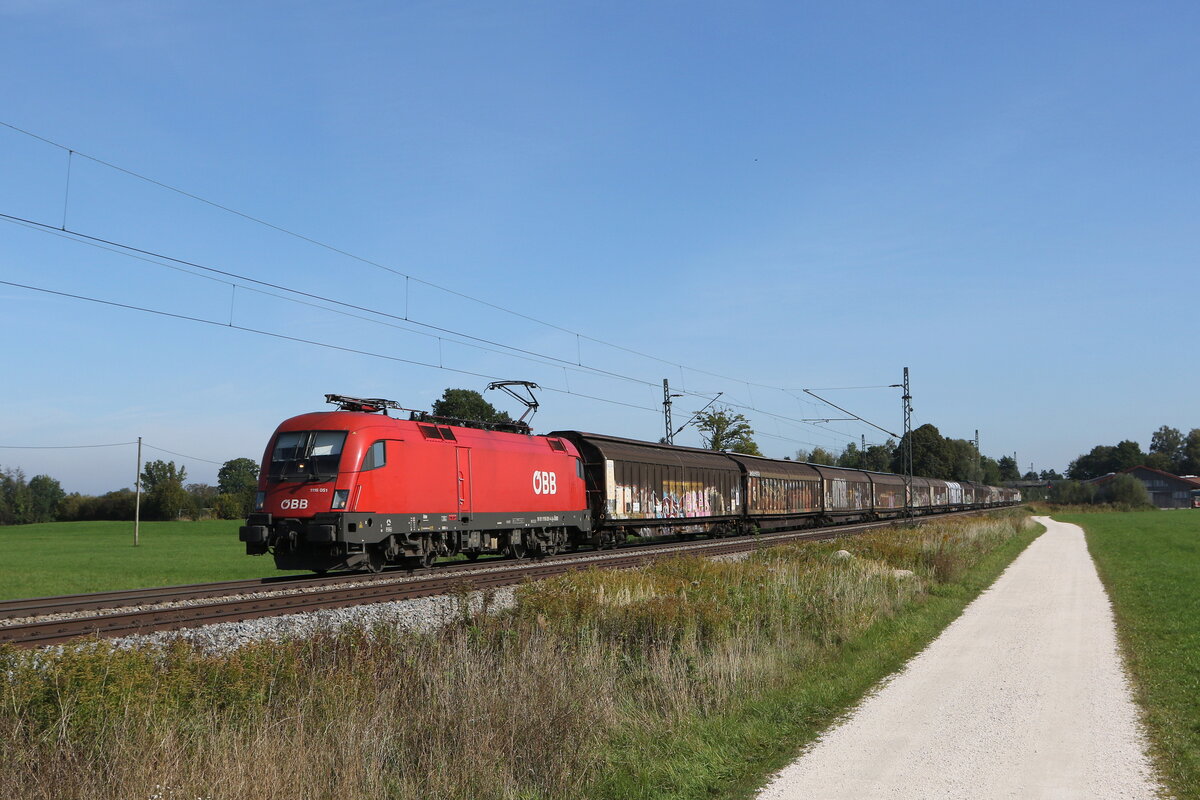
[{"left": 0, "top": 516, "right": 1022, "bottom": 800}]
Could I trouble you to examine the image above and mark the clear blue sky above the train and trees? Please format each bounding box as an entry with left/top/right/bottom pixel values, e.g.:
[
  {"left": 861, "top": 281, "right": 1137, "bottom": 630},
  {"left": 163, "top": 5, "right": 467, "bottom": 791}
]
[{"left": 0, "top": 0, "right": 1200, "bottom": 492}]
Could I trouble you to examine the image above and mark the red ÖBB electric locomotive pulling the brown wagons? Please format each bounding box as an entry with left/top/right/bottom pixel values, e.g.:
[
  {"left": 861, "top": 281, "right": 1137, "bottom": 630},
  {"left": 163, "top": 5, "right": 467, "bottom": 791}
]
[{"left": 240, "top": 395, "right": 592, "bottom": 572}]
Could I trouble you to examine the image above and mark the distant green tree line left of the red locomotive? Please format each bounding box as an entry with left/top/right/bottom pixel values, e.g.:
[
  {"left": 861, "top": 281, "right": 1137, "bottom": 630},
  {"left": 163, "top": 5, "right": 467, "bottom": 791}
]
[{"left": 0, "top": 458, "right": 258, "bottom": 525}]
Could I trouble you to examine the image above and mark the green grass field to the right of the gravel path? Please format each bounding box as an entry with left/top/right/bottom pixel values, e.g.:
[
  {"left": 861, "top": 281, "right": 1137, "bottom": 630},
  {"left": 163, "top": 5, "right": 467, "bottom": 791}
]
[{"left": 1055, "top": 510, "right": 1200, "bottom": 800}]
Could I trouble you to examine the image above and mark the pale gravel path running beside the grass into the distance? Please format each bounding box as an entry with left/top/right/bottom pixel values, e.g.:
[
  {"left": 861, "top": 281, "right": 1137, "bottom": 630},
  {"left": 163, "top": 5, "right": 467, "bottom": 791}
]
[{"left": 758, "top": 517, "right": 1157, "bottom": 800}]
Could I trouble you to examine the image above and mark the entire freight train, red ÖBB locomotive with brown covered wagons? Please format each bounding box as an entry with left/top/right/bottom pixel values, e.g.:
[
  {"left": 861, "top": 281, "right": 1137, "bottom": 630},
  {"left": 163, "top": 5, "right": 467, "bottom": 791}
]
[{"left": 239, "top": 395, "right": 1021, "bottom": 572}]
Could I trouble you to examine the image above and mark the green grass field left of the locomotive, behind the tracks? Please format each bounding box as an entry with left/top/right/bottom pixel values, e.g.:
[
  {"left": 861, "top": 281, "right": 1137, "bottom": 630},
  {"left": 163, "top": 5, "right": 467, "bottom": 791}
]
[{"left": 0, "top": 519, "right": 302, "bottom": 600}]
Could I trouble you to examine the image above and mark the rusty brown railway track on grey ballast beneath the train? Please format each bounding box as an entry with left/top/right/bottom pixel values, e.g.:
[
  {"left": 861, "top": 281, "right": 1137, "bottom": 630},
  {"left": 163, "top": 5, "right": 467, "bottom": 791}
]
[{"left": 0, "top": 511, "right": 980, "bottom": 648}]
